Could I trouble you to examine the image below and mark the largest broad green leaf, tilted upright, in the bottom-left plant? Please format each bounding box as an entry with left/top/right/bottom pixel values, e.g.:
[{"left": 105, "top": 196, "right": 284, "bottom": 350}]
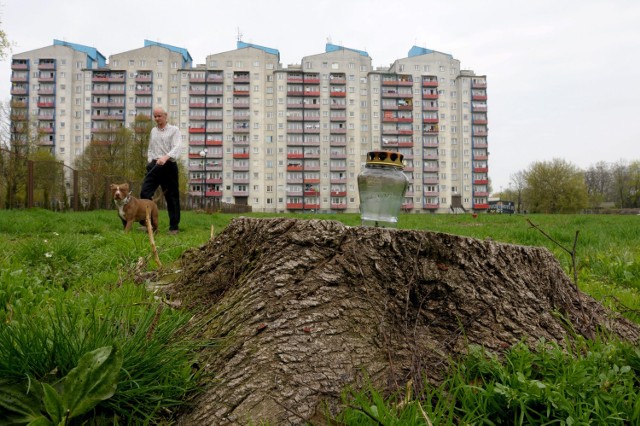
[{"left": 62, "top": 345, "right": 122, "bottom": 419}]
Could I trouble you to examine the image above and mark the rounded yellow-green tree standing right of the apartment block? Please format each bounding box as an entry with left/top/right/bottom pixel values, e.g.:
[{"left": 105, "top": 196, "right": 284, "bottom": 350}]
[{"left": 524, "top": 158, "right": 588, "bottom": 213}]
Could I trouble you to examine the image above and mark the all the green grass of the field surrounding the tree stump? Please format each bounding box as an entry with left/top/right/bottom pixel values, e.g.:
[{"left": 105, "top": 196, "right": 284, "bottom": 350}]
[{"left": 0, "top": 210, "right": 640, "bottom": 424}]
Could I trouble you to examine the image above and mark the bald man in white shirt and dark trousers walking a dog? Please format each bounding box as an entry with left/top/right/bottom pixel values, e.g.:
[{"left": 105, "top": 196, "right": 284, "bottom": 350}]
[{"left": 140, "top": 107, "right": 182, "bottom": 235}]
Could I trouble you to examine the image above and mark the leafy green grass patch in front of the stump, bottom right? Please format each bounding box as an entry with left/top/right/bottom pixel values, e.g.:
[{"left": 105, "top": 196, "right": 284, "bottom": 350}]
[{"left": 333, "top": 339, "right": 640, "bottom": 425}]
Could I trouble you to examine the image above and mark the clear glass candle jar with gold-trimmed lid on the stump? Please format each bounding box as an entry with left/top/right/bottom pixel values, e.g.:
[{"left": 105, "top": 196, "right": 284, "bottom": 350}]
[{"left": 358, "top": 151, "right": 409, "bottom": 228}]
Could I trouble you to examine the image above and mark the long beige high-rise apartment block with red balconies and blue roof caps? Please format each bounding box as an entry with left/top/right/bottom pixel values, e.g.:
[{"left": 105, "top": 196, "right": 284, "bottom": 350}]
[{"left": 11, "top": 41, "right": 489, "bottom": 213}]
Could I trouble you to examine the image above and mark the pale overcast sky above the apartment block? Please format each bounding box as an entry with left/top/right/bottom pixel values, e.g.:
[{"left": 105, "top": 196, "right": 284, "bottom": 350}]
[{"left": 0, "top": 0, "right": 640, "bottom": 191}]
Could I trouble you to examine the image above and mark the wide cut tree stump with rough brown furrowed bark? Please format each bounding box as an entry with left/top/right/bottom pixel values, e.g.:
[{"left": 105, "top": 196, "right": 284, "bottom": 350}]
[{"left": 166, "top": 218, "right": 640, "bottom": 425}]
